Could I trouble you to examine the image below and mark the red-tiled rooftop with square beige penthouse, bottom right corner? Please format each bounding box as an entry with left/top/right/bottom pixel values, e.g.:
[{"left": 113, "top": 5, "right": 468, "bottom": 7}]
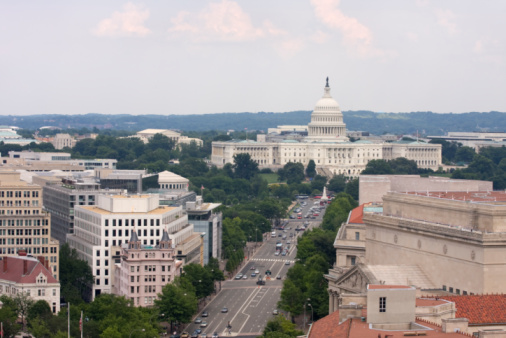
[{"left": 307, "top": 285, "right": 506, "bottom": 338}]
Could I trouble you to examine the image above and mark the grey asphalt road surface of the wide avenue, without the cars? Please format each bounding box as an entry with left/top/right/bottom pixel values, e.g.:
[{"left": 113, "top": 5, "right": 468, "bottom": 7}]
[{"left": 186, "top": 200, "right": 323, "bottom": 337}]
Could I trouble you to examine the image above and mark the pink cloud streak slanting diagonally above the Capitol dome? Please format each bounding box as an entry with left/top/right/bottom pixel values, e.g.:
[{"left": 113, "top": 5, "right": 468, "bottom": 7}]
[{"left": 311, "top": 0, "right": 384, "bottom": 57}]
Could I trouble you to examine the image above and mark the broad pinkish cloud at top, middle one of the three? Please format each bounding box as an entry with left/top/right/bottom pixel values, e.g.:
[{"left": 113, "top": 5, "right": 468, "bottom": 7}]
[{"left": 169, "top": 0, "right": 286, "bottom": 41}]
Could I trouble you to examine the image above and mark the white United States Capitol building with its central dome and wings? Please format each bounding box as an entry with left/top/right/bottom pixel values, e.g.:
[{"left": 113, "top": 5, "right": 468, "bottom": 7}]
[{"left": 211, "top": 78, "right": 441, "bottom": 177}]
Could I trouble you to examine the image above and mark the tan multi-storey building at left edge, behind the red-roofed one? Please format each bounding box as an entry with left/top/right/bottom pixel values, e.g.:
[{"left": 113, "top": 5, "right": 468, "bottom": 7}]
[{"left": 0, "top": 172, "right": 59, "bottom": 279}]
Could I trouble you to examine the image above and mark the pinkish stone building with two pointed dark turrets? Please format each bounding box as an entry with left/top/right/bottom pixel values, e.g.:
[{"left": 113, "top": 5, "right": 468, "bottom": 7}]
[{"left": 113, "top": 230, "right": 182, "bottom": 306}]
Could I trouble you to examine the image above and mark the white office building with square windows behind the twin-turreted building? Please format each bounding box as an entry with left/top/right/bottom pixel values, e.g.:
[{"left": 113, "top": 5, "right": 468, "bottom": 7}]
[{"left": 67, "top": 195, "right": 201, "bottom": 297}]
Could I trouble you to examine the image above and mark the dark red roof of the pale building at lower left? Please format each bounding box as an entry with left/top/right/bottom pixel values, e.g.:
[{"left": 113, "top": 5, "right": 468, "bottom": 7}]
[{"left": 0, "top": 257, "right": 58, "bottom": 284}]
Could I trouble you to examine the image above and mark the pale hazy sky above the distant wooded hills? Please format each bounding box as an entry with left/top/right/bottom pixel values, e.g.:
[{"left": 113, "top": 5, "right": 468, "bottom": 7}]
[{"left": 0, "top": 0, "right": 506, "bottom": 115}]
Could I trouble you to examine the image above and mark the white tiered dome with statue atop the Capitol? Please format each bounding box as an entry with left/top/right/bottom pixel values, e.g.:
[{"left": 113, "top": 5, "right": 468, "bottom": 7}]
[{"left": 307, "top": 78, "right": 348, "bottom": 142}]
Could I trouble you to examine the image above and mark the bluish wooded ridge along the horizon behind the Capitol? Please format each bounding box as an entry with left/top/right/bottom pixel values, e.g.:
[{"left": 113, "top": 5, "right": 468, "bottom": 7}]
[{"left": 0, "top": 111, "right": 506, "bottom": 135}]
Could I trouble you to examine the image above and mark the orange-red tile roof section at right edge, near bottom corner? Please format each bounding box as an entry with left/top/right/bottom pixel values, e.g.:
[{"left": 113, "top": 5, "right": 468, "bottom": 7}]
[{"left": 439, "top": 294, "right": 506, "bottom": 325}]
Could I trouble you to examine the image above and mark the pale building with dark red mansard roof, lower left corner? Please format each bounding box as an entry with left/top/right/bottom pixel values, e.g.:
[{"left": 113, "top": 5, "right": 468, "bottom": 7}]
[{"left": 0, "top": 256, "right": 60, "bottom": 313}]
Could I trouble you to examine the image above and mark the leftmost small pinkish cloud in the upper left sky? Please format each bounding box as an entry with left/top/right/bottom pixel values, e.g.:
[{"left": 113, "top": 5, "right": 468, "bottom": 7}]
[{"left": 93, "top": 2, "right": 151, "bottom": 37}]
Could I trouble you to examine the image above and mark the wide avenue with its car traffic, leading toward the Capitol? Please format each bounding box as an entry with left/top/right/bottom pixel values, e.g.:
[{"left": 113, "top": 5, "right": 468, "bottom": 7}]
[{"left": 181, "top": 199, "right": 325, "bottom": 338}]
